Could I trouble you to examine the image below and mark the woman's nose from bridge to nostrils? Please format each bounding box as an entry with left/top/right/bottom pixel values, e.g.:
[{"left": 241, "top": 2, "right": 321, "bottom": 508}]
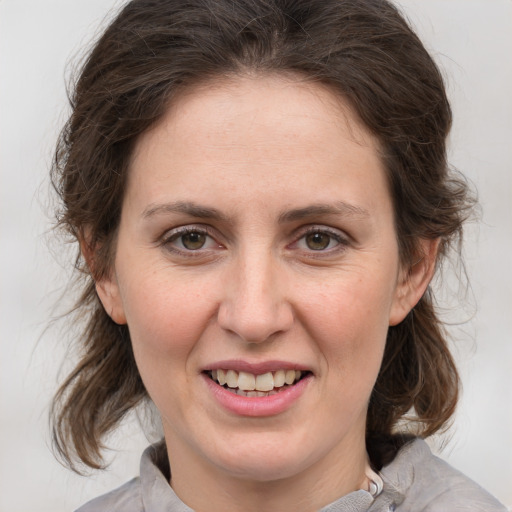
[{"left": 218, "top": 249, "right": 293, "bottom": 343}]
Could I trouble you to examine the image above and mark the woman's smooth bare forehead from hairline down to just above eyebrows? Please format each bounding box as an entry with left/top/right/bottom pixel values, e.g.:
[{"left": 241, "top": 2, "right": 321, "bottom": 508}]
[{"left": 128, "top": 75, "right": 387, "bottom": 216}]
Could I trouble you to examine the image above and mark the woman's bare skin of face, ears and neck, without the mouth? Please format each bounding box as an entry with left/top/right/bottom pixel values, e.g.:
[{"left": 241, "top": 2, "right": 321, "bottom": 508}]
[{"left": 97, "top": 76, "right": 436, "bottom": 512}]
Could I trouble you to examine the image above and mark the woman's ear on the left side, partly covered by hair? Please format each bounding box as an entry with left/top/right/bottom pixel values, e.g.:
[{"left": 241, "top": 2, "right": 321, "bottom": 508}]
[{"left": 80, "top": 231, "right": 126, "bottom": 325}]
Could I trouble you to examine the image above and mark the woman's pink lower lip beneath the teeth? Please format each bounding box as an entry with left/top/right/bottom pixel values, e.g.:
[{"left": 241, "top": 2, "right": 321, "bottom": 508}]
[{"left": 203, "top": 374, "right": 312, "bottom": 417}]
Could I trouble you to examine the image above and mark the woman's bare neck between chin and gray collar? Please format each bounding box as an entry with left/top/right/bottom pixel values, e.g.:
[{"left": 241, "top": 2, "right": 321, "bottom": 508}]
[{"left": 168, "top": 438, "right": 368, "bottom": 512}]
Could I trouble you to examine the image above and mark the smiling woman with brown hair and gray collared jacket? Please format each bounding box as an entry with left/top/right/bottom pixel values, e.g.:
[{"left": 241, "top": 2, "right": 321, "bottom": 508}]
[{"left": 53, "top": 0, "right": 504, "bottom": 512}]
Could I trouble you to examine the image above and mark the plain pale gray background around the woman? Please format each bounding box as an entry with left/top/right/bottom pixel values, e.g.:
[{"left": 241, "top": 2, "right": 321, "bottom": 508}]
[{"left": 0, "top": 0, "right": 512, "bottom": 512}]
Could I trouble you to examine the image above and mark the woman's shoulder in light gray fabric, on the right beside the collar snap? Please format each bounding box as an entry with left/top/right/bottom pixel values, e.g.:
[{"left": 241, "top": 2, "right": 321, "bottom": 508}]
[{"left": 382, "top": 439, "right": 506, "bottom": 512}]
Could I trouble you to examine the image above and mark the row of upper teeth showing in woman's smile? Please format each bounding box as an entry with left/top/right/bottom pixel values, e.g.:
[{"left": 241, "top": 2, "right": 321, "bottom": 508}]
[{"left": 211, "top": 369, "right": 302, "bottom": 391}]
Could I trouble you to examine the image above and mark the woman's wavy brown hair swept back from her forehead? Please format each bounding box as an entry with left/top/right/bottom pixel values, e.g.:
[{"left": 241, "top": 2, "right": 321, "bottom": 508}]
[{"left": 52, "top": 0, "right": 470, "bottom": 468}]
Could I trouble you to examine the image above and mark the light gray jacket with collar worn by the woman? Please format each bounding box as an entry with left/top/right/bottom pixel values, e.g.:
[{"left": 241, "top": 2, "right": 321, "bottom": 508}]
[{"left": 77, "top": 439, "right": 507, "bottom": 512}]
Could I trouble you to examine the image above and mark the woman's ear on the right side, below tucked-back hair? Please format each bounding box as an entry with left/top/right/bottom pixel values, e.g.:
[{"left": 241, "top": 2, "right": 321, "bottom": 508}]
[{"left": 389, "top": 238, "right": 440, "bottom": 325}]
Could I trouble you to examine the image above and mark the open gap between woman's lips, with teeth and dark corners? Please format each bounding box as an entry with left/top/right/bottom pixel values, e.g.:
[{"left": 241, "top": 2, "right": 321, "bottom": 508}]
[{"left": 205, "top": 368, "right": 311, "bottom": 397}]
